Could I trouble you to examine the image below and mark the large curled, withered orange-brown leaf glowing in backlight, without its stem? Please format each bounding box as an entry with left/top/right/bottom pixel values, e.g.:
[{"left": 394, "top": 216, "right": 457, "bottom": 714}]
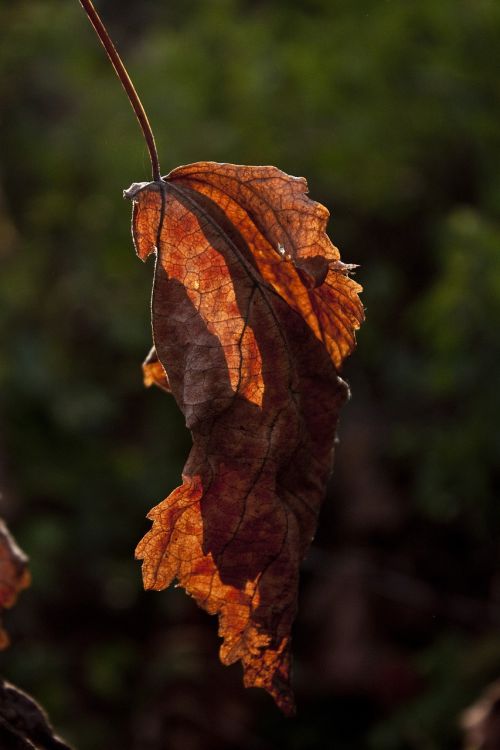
[{"left": 129, "top": 162, "right": 363, "bottom": 714}]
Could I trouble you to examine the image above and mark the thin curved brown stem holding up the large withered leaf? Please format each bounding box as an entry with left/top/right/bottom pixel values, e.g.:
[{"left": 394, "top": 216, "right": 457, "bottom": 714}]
[{"left": 80, "top": 0, "right": 161, "bottom": 182}]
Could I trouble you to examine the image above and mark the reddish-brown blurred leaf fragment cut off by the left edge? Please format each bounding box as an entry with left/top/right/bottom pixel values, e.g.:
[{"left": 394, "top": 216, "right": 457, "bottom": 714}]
[{"left": 0, "top": 519, "right": 31, "bottom": 649}]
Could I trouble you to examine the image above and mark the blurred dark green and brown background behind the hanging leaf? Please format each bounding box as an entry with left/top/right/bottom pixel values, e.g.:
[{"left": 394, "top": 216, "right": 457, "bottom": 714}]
[{"left": 0, "top": 0, "right": 500, "bottom": 750}]
